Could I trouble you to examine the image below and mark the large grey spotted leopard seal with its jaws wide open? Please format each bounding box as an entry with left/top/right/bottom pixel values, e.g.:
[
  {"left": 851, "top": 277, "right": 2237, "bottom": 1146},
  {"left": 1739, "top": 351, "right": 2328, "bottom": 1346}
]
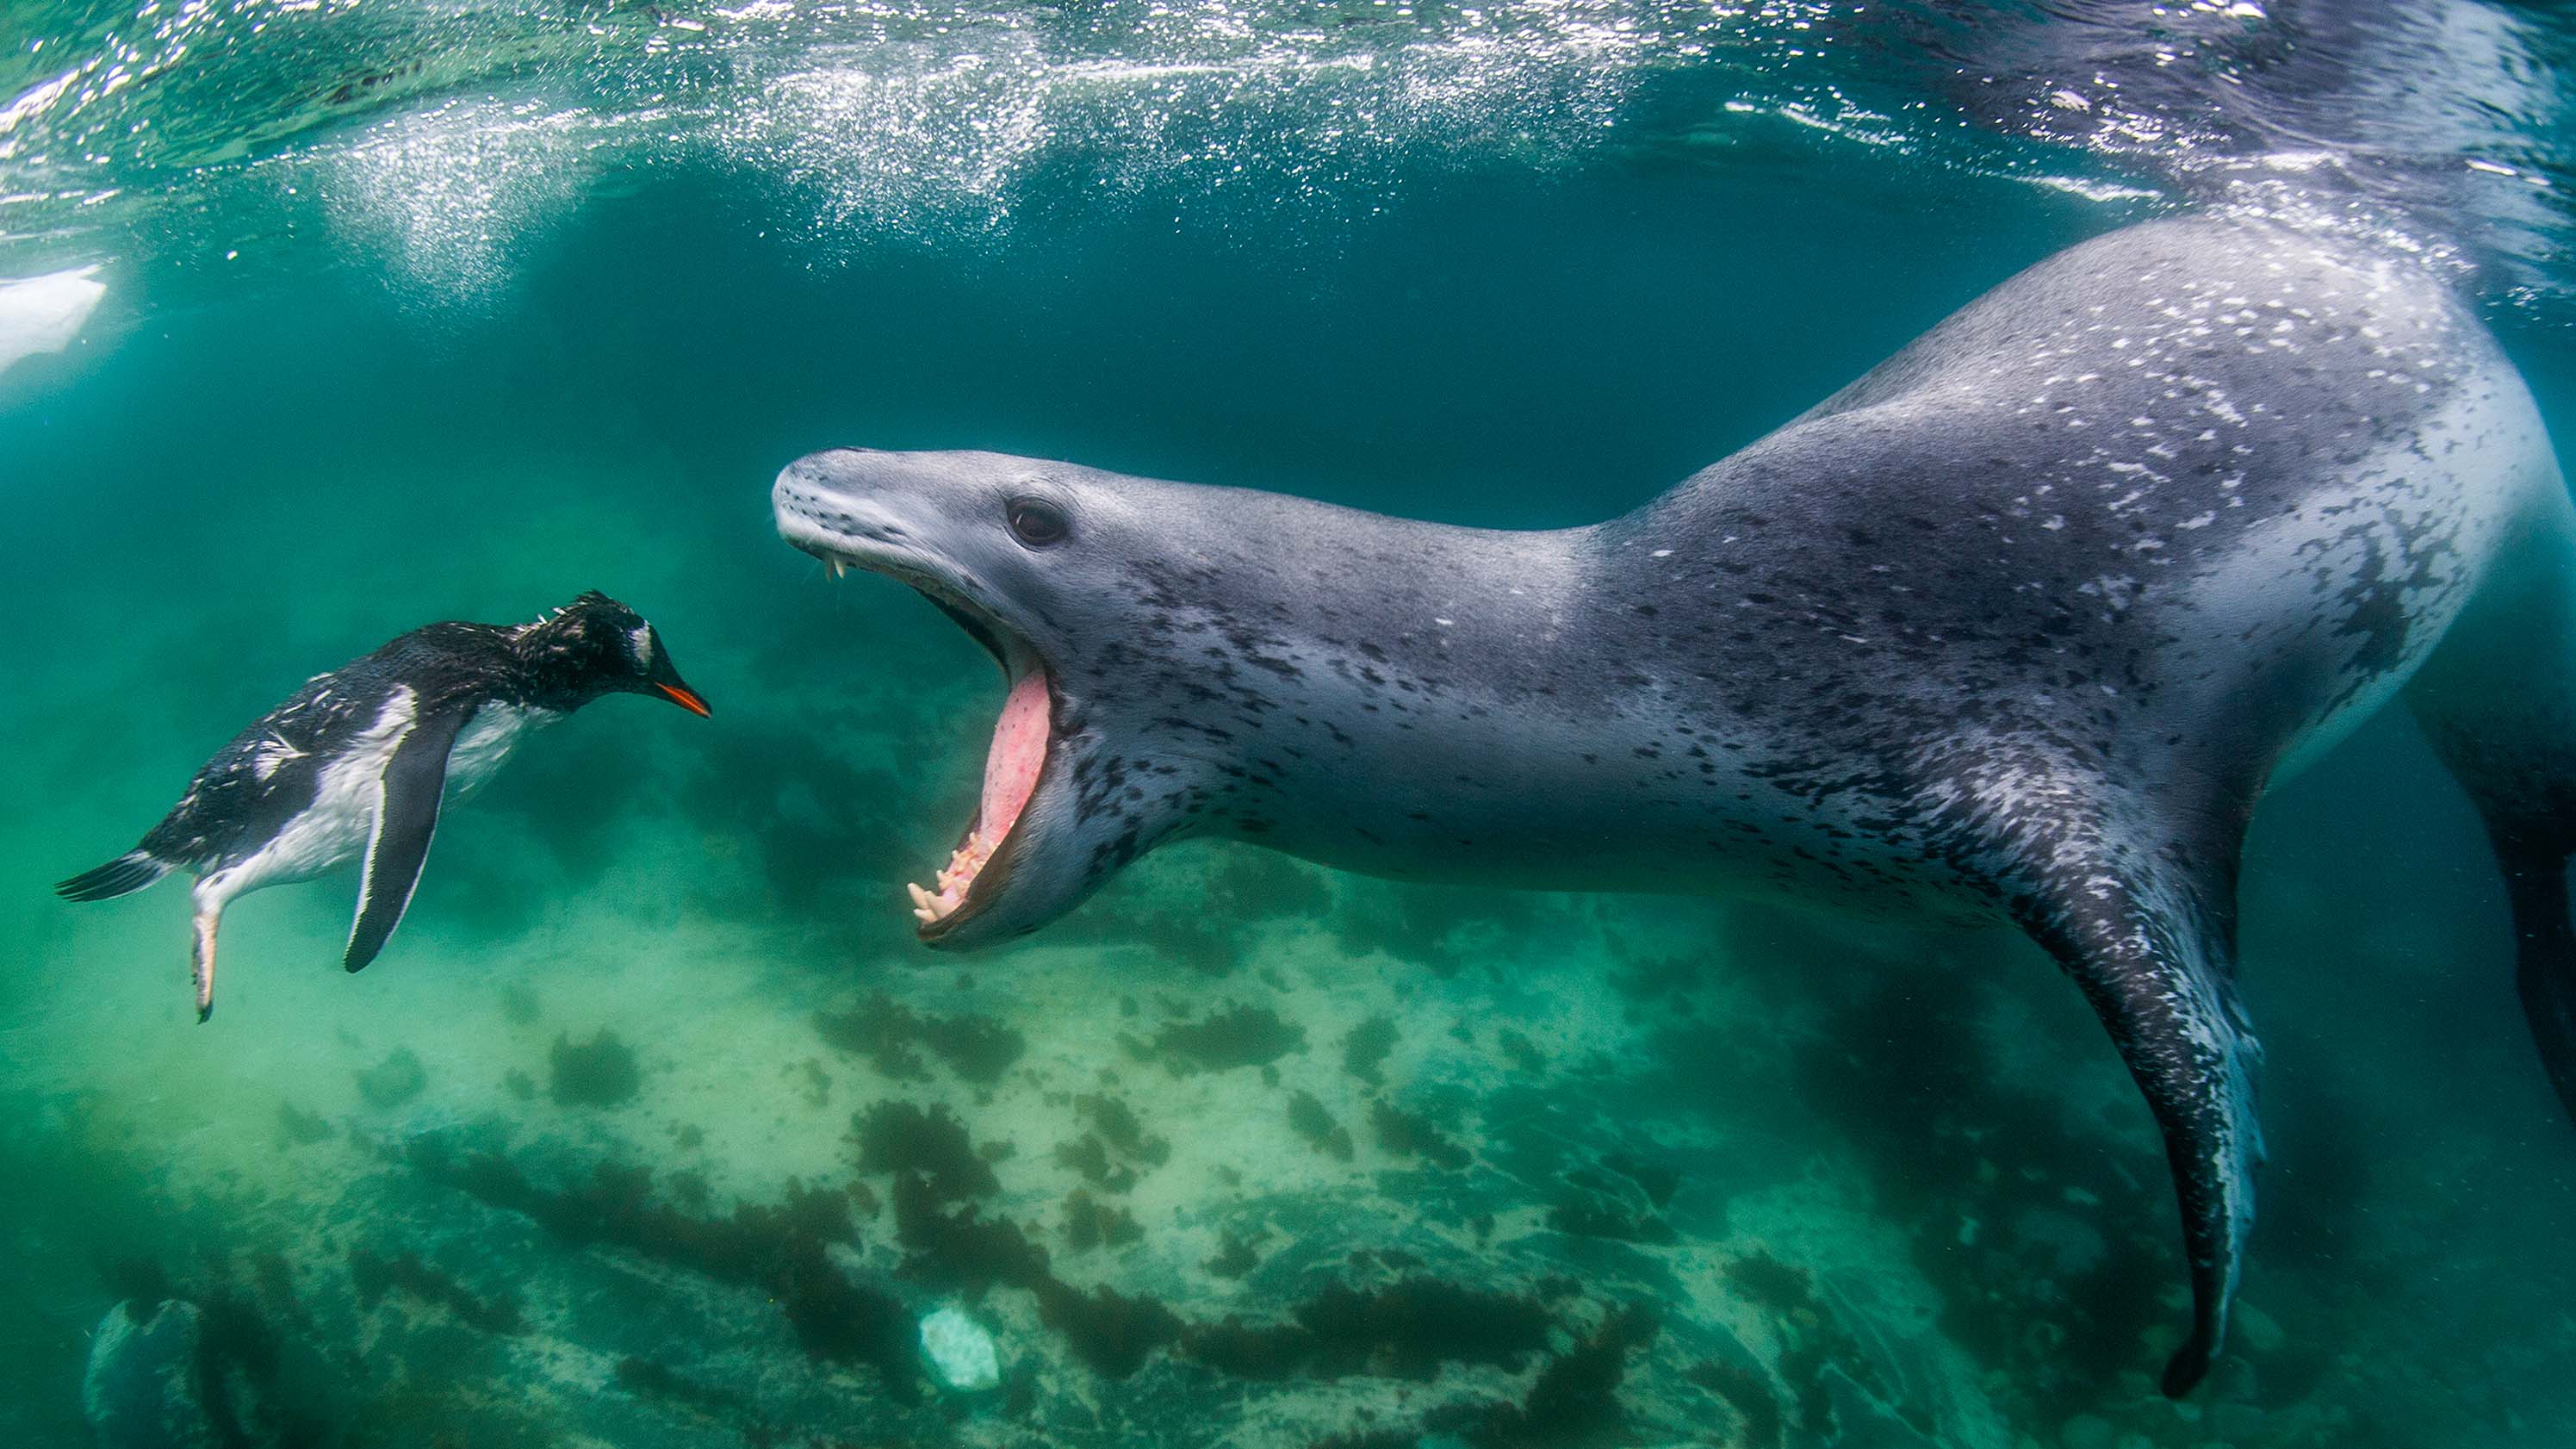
[{"left": 773, "top": 216, "right": 2576, "bottom": 1395}]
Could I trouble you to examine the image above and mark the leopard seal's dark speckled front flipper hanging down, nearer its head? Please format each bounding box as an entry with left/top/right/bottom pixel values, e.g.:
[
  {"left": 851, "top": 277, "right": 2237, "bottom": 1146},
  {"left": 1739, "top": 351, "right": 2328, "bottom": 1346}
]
[{"left": 2014, "top": 843, "right": 2262, "bottom": 1397}]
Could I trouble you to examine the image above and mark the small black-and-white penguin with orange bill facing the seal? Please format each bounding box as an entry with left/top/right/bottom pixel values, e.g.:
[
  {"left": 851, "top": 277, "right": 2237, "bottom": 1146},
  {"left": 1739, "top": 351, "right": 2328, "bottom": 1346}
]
[{"left": 54, "top": 590, "right": 706, "bottom": 1021}]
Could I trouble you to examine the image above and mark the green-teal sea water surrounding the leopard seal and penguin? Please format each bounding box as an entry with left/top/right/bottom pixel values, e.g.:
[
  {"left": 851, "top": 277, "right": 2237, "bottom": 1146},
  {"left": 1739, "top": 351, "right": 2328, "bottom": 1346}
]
[{"left": 0, "top": 0, "right": 2576, "bottom": 1449}]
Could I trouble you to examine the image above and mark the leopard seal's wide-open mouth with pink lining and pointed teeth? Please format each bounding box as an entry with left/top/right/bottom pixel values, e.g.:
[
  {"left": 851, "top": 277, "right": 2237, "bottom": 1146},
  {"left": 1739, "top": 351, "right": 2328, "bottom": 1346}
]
[{"left": 798, "top": 544, "right": 1056, "bottom": 941}]
